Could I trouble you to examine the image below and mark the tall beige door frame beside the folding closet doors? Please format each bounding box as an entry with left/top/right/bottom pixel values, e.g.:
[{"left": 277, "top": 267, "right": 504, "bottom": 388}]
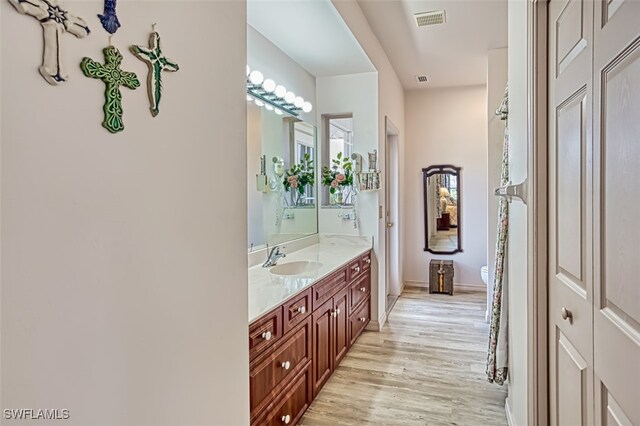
[{"left": 527, "top": 0, "right": 549, "bottom": 424}]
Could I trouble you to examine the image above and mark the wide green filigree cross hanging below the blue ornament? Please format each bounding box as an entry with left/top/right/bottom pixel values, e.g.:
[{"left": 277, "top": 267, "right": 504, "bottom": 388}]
[{"left": 80, "top": 46, "right": 140, "bottom": 133}]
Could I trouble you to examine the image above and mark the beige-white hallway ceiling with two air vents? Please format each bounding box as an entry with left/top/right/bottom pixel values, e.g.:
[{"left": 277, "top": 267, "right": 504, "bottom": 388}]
[{"left": 358, "top": 0, "right": 507, "bottom": 90}]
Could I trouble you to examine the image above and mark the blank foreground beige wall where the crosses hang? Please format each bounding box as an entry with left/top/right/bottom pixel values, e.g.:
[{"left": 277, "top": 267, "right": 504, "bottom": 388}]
[{"left": 0, "top": 0, "right": 249, "bottom": 426}]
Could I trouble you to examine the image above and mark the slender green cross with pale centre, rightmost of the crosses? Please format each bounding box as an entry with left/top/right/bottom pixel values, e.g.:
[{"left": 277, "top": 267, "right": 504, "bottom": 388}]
[{"left": 130, "top": 29, "right": 180, "bottom": 117}]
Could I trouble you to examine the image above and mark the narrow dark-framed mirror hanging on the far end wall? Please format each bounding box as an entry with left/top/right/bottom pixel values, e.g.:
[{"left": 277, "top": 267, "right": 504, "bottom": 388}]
[{"left": 422, "top": 165, "right": 462, "bottom": 254}]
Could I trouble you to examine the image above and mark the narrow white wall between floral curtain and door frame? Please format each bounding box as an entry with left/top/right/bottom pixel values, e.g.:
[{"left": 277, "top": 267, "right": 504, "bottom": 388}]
[{"left": 507, "top": 0, "right": 532, "bottom": 426}]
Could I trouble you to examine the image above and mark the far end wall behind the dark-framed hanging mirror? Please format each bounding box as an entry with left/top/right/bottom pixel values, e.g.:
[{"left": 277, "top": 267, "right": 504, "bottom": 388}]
[{"left": 404, "top": 86, "right": 487, "bottom": 284}]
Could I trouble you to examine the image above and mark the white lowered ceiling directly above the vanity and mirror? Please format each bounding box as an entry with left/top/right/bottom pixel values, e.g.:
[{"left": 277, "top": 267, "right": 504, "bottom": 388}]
[{"left": 247, "top": 0, "right": 375, "bottom": 77}]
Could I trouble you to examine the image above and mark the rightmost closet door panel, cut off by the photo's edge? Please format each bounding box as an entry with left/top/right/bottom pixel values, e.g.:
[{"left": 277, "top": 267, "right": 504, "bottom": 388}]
[{"left": 593, "top": 0, "right": 640, "bottom": 425}]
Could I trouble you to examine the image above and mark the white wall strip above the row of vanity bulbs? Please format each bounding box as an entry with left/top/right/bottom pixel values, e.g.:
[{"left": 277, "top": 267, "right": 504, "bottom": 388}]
[{"left": 247, "top": 25, "right": 316, "bottom": 126}]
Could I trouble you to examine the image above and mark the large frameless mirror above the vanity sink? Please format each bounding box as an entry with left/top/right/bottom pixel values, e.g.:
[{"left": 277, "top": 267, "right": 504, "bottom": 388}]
[{"left": 248, "top": 103, "right": 318, "bottom": 251}]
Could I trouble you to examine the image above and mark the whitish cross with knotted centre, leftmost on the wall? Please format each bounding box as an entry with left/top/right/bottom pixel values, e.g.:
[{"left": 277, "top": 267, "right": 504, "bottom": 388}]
[{"left": 9, "top": 0, "right": 90, "bottom": 86}]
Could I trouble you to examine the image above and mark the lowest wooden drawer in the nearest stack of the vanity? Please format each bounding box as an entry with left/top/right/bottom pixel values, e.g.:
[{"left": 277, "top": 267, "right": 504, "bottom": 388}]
[{"left": 253, "top": 363, "right": 312, "bottom": 426}]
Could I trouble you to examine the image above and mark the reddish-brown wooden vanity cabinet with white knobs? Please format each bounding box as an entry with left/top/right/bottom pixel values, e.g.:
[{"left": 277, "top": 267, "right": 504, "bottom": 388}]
[{"left": 249, "top": 252, "right": 371, "bottom": 426}]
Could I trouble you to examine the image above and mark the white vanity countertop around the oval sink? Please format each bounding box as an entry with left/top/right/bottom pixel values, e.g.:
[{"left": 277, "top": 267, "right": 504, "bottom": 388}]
[{"left": 249, "top": 235, "right": 372, "bottom": 323}]
